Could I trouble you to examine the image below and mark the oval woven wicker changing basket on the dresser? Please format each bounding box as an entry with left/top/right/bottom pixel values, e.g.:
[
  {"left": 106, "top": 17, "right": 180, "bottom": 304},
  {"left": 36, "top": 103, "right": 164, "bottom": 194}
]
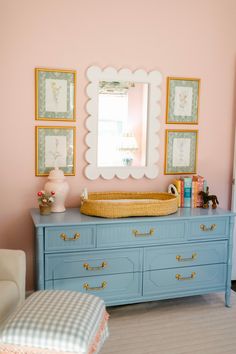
[{"left": 80, "top": 192, "right": 178, "bottom": 218}]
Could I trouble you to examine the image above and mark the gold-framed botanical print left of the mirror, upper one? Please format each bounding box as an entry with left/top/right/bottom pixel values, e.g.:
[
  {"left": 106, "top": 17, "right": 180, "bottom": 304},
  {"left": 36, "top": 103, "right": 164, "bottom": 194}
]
[{"left": 35, "top": 68, "right": 76, "bottom": 121}]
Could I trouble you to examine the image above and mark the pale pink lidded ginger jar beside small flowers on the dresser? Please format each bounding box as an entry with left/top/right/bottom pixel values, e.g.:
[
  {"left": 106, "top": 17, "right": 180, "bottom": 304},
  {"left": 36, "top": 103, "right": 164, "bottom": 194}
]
[{"left": 44, "top": 167, "right": 69, "bottom": 213}]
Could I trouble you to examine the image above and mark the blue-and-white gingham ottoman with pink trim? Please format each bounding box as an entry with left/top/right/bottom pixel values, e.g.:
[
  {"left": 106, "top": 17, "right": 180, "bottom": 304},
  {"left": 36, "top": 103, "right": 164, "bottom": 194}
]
[{"left": 0, "top": 290, "right": 108, "bottom": 354}]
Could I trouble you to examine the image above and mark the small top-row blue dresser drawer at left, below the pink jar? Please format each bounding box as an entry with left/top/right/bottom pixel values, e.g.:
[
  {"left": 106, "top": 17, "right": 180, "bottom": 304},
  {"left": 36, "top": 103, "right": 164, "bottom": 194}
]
[{"left": 45, "top": 226, "right": 95, "bottom": 251}]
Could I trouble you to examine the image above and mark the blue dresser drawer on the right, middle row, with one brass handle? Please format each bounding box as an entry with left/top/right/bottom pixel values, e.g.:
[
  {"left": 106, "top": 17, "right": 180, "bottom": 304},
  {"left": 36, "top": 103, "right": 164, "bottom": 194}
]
[{"left": 144, "top": 241, "right": 227, "bottom": 271}]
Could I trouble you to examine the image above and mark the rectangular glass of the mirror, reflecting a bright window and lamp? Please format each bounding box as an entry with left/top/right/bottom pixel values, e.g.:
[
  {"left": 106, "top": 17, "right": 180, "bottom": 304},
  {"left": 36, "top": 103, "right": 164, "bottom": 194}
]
[{"left": 97, "top": 81, "right": 148, "bottom": 167}]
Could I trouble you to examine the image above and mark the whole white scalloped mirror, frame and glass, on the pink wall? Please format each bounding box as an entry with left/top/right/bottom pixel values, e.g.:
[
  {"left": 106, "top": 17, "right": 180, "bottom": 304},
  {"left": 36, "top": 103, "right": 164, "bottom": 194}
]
[{"left": 85, "top": 66, "right": 161, "bottom": 180}]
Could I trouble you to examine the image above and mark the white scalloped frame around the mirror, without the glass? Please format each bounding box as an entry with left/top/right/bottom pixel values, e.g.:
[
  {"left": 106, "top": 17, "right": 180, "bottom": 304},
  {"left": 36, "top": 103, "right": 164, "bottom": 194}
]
[{"left": 85, "top": 66, "right": 162, "bottom": 180}]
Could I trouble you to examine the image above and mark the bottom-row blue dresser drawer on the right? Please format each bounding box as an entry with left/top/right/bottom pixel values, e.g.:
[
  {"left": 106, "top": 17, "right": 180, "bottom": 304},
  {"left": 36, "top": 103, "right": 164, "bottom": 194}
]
[{"left": 143, "top": 264, "right": 226, "bottom": 296}]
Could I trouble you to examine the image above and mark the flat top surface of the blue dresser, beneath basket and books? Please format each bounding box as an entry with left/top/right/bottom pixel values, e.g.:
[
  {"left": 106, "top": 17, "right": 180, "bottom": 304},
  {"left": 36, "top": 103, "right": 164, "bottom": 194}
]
[{"left": 30, "top": 208, "right": 236, "bottom": 227}]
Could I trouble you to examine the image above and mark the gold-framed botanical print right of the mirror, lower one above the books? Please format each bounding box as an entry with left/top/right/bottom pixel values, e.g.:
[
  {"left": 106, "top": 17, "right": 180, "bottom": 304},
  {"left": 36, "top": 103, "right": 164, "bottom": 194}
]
[{"left": 164, "top": 129, "right": 198, "bottom": 175}]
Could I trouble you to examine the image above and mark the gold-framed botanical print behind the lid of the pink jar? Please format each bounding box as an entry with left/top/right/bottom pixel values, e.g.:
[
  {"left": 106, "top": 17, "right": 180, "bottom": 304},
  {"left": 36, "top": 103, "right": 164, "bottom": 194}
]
[{"left": 35, "top": 126, "right": 75, "bottom": 176}]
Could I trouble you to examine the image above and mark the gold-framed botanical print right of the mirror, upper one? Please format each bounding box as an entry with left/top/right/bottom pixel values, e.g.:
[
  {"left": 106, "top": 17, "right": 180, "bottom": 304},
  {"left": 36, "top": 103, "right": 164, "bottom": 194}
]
[{"left": 166, "top": 77, "right": 200, "bottom": 124}]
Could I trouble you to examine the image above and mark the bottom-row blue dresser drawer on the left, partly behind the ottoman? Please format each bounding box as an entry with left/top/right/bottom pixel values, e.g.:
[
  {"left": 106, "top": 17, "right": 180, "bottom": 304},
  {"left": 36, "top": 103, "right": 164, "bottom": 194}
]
[{"left": 46, "top": 272, "right": 142, "bottom": 301}]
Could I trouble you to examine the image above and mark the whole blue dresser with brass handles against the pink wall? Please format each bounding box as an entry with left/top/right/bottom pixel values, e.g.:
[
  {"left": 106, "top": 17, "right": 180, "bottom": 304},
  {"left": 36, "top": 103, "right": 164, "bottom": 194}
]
[{"left": 31, "top": 208, "right": 234, "bottom": 306}]
